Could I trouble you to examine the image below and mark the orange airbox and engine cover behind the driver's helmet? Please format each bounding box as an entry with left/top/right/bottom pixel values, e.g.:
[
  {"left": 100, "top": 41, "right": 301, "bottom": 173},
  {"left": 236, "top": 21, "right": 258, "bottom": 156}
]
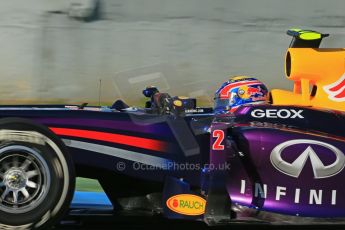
[{"left": 271, "top": 29, "right": 345, "bottom": 111}]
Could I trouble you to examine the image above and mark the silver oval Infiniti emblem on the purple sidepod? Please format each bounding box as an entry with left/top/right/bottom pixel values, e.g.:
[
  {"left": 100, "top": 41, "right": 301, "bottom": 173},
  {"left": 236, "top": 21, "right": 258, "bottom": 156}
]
[{"left": 270, "top": 139, "right": 345, "bottom": 179}]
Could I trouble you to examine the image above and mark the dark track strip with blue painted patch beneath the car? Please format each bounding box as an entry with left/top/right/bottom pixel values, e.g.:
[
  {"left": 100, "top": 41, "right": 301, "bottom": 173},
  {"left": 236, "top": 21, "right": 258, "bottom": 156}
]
[{"left": 53, "top": 192, "right": 345, "bottom": 230}]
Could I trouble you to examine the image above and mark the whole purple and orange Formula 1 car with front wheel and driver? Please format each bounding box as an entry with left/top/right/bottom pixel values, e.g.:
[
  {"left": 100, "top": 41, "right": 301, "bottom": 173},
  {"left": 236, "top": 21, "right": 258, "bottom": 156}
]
[{"left": 0, "top": 29, "right": 345, "bottom": 229}]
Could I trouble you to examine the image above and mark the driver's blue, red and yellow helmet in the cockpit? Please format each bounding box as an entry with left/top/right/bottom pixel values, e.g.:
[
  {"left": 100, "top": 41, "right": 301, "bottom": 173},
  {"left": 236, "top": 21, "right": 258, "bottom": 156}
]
[{"left": 214, "top": 76, "right": 268, "bottom": 113}]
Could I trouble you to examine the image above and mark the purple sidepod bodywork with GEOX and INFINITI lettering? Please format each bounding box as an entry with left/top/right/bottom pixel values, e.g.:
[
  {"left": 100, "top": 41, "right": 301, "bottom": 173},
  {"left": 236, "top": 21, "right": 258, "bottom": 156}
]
[{"left": 211, "top": 106, "right": 345, "bottom": 222}]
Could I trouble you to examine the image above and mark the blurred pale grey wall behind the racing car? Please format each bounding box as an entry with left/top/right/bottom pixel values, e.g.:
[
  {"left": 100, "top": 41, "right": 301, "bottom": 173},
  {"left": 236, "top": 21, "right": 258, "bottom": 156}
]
[{"left": 0, "top": 0, "right": 345, "bottom": 106}]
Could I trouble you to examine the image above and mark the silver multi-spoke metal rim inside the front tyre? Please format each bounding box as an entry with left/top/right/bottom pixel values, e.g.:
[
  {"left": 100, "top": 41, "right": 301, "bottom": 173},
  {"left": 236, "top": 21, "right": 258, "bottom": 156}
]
[{"left": 0, "top": 145, "right": 51, "bottom": 213}]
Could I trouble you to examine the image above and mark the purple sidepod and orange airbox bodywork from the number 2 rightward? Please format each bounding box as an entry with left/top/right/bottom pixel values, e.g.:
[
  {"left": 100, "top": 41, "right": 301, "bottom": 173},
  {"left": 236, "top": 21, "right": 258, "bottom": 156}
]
[{"left": 210, "top": 31, "right": 345, "bottom": 223}]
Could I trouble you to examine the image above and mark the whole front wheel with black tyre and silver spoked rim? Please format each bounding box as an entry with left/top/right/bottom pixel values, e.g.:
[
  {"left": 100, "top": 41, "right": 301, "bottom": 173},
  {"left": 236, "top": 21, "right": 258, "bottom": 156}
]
[{"left": 0, "top": 118, "right": 75, "bottom": 230}]
